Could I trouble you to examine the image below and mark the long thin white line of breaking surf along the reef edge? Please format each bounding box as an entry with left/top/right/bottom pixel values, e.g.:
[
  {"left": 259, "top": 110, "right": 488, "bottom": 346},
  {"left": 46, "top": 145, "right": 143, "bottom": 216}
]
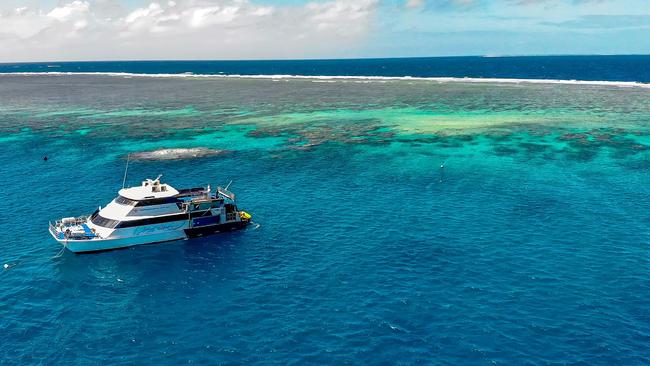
[{"left": 0, "top": 71, "right": 650, "bottom": 89}]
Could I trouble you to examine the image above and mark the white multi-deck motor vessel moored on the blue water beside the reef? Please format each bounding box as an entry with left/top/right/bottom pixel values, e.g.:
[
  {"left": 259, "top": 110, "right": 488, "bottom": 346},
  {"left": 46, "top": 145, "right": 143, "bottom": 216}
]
[{"left": 50, "top": 176, "right": 251, "bottom": 253}]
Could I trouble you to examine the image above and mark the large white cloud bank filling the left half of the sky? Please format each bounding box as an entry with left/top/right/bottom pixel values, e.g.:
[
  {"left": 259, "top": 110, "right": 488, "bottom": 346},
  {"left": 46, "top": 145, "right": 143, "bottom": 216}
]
[{"left": 0, "top": 0, "right": 378, "bottom": 61}]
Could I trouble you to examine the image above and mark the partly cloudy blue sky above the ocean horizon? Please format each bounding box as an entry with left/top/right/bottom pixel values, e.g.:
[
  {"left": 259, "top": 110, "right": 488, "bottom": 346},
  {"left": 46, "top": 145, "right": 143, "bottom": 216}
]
[{"left": 0, "top": 0, "right": 650, "bottom": 62}]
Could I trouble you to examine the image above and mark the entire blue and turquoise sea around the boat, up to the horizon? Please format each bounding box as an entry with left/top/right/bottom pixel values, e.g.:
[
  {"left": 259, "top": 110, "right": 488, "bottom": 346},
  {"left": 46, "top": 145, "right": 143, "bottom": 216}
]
[{"left": 0, "top": 56, "right": 650, "bottom": 365}]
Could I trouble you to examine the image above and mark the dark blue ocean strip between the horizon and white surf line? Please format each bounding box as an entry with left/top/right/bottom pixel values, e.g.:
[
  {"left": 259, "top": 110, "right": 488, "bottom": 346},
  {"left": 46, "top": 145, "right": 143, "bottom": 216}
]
[{"left": 0, "top": 55, "right": 650, "bottom": 83}]
